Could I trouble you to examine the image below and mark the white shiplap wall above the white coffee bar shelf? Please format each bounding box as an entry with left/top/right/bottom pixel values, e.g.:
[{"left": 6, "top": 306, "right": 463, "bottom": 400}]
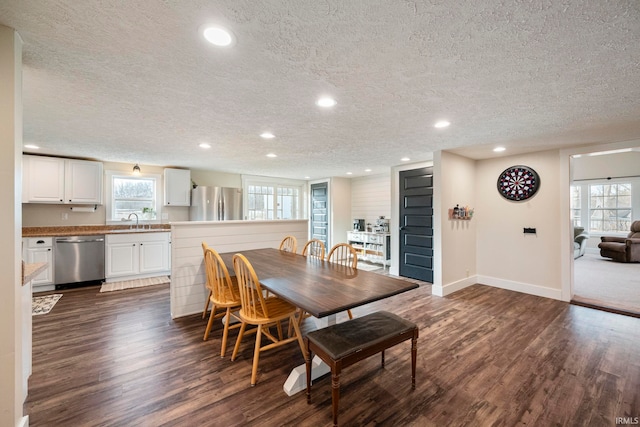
[{"left": 351, "top": 172, "right": 391, "bottom": 229}]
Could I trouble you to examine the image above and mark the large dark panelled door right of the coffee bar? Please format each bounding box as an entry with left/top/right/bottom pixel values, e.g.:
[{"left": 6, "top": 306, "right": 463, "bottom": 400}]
[{"left": 399, "top": 166, "right": 433, "bottom": 283}]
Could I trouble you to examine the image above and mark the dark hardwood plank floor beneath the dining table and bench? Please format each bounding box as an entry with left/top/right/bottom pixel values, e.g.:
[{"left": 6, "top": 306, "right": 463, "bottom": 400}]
[{"left": 25, "top": 285, "right": 640, "bottom": 426}]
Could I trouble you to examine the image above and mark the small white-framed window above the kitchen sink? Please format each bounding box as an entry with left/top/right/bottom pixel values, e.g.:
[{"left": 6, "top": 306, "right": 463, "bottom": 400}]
[{"left": 106, "top": 171, "right": 160, "bottom": 223}]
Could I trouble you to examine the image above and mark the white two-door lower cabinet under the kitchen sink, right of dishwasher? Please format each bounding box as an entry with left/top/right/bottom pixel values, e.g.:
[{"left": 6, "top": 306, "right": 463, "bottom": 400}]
[{"left": 105, "top": 232, "right": 171, "bottom": 281}]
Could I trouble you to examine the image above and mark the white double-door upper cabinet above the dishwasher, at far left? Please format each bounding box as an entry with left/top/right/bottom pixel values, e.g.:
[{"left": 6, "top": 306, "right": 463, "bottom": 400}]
[{"left": 22, "top": 156, "right": 103, "bottom": 205}]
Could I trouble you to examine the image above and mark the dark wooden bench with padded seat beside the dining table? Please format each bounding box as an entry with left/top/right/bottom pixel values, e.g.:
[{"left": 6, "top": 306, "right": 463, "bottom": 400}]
[{"left": 305, "top": 311, "right": 418, "bottom": 426}]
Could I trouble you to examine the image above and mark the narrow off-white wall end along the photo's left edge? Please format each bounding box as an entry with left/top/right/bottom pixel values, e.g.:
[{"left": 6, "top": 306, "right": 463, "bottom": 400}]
[{"left": 0, "top": 25, "right": 26, "bottom": 426}]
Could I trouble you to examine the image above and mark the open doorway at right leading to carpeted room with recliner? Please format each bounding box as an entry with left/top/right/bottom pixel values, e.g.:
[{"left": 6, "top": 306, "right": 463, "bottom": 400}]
[{"left": 570, "top": 149, "right": 640, "bottom": 317}]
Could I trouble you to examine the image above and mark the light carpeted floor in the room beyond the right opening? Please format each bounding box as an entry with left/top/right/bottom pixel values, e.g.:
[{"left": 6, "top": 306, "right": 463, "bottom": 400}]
[{"left": 574, "top": 254, "right": 640, "bottom": 313}]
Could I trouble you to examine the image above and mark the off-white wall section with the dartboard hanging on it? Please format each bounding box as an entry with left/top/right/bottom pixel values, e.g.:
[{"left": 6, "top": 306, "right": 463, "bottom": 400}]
[{"left": 472, "top": 151, "right": 562, "bottom": 299}]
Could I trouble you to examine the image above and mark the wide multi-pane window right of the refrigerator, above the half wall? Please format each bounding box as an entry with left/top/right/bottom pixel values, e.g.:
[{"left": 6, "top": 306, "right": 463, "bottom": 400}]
[{"left": 243, "top": 176, "right": 306, "bottom": 220}]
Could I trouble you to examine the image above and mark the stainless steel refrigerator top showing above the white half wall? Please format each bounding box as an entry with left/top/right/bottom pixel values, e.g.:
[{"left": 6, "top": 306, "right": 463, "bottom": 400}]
[{"left": 189, "top": 186, "right": 242, "bottom": 221}]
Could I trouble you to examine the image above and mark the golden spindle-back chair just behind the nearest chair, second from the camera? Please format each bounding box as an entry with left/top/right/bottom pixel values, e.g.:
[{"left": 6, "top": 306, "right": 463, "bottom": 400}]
[{"left": 202, "top": 242, "right": 241, "bottom": 357}]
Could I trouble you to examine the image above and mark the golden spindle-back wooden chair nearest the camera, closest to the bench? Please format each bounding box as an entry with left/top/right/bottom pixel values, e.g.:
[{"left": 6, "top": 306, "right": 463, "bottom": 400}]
[{"left": 231, "top": 254, "right": 306, "bottom": 386}]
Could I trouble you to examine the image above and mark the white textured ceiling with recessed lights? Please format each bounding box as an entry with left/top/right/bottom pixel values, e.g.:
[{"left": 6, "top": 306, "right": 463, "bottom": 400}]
[{"left": 0, "top": 0, "right": 640, "bottom": 178}]
